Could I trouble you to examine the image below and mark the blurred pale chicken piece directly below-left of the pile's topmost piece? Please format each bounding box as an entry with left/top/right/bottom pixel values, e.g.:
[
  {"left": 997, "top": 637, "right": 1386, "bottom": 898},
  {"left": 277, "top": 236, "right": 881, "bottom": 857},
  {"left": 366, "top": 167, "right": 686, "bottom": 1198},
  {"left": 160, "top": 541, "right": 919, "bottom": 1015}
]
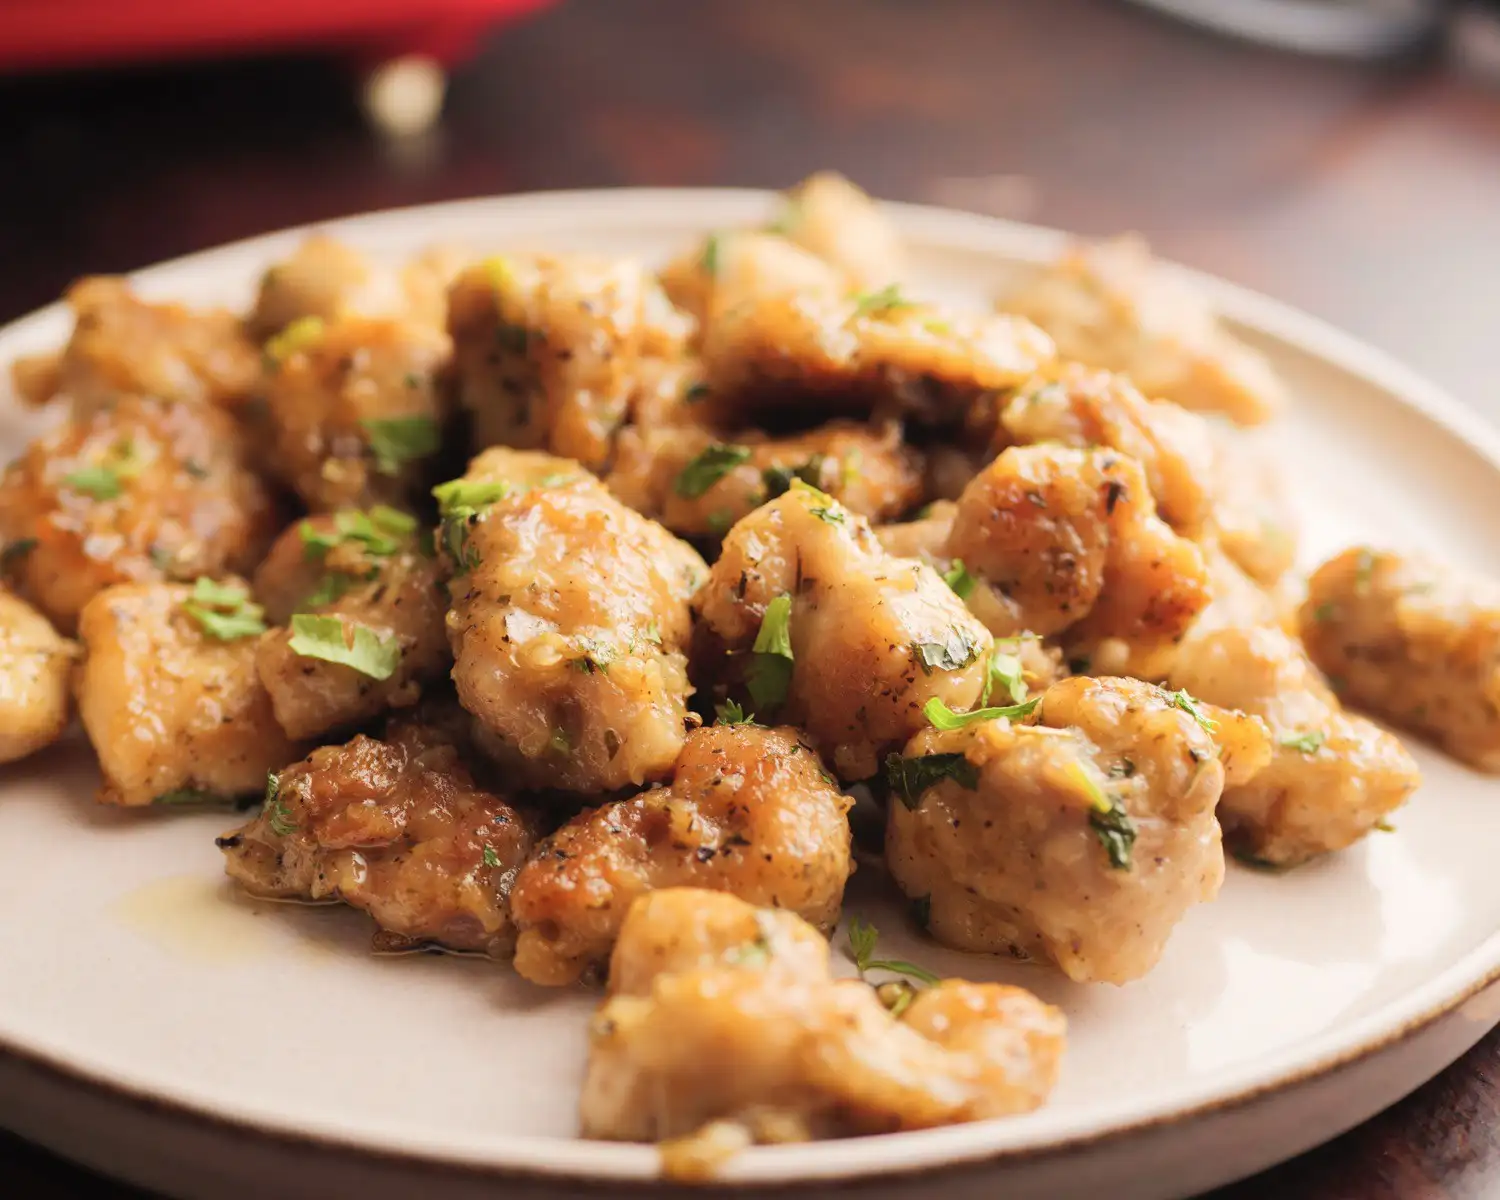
[{"left": 662, "top": 230, "right": 849, "bottom": 327}]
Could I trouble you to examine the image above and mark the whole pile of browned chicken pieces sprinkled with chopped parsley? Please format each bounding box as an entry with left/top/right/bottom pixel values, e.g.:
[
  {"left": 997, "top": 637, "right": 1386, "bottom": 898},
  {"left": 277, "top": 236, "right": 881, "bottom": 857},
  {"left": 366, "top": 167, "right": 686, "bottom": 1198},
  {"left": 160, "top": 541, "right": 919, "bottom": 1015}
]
[{"left": 0, "top": 176, "right": 1500, "bottom": 1173}]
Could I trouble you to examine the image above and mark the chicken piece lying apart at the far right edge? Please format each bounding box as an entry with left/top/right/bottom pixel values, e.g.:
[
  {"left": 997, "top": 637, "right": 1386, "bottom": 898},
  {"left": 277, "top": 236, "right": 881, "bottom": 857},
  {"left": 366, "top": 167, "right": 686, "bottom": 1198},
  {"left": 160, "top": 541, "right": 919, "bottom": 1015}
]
[{"left": 1299, "top": 549, "right": 1500, "bottom": 771}]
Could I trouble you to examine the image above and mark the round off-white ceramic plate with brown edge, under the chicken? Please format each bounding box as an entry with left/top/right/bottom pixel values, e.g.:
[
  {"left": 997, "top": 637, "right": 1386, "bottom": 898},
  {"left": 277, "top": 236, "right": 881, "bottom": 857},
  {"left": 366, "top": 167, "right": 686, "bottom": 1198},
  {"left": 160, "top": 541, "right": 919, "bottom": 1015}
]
[{"left": 0, "top": 191, "right": 1500, "bottom": 1200}]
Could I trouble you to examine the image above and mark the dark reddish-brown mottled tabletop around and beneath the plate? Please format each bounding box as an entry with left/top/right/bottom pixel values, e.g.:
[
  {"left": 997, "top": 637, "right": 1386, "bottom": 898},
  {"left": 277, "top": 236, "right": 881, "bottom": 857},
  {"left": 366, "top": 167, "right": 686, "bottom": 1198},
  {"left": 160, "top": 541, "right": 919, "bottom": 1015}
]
[{"left": 0, "top": 0, "right": 1500, "bottom": 1200}]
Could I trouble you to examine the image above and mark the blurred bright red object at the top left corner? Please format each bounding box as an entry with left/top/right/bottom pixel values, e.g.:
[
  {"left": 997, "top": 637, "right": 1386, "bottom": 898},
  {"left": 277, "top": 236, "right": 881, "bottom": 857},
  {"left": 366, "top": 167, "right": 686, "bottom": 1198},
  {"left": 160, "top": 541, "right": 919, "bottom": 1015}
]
[{"left": 0, "top": 0, "right": 552, "bottom": 71}]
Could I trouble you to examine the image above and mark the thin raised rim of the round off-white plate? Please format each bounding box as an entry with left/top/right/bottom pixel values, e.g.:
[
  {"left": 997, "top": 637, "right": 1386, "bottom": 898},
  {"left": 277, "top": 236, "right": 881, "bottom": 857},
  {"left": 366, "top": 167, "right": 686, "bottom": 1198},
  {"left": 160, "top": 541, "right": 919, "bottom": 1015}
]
[{"left": 0, "top": 188, "right": 1500, "bottom": 1187}]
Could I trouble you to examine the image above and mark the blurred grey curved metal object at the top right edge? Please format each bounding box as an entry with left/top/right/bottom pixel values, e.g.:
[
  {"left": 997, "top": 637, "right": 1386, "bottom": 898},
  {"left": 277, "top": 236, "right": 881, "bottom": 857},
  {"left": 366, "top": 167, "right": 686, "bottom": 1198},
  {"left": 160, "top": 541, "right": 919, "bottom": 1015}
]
[{"left": 1136, "top": 0, "right": 1446, "bottom": 59}]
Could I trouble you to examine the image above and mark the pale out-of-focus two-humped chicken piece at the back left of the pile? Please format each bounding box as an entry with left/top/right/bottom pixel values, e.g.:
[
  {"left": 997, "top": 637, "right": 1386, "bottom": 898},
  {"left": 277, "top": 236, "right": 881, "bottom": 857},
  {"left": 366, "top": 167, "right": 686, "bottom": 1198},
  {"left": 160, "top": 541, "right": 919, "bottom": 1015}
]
[{"left": 251, "top": 234, "right": 462, "bottom": 339}]
